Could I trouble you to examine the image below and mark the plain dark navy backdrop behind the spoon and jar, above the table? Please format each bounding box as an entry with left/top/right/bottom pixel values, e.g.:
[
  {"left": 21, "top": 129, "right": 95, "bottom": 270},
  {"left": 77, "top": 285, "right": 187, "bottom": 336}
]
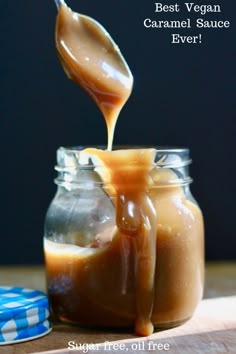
[{"left": 0, "top": 0, "right": 236, "bottom": 264}]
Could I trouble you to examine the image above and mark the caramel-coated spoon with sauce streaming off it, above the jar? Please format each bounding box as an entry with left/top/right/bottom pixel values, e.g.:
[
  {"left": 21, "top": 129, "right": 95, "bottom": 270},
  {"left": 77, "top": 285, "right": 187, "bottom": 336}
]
[{"left": 55, "top": 0, "right": 133, "bottom": 150}]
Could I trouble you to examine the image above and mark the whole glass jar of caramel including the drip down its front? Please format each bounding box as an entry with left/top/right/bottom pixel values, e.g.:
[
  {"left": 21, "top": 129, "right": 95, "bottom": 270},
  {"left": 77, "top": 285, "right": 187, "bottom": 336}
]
[{"left": 45, "top": 149, "right": 204, "bottom": 336}]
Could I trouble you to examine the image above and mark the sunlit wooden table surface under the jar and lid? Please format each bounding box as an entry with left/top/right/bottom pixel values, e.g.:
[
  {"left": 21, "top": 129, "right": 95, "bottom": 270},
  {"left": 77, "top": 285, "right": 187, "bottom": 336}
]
[{"left": 0, "top": 262, "right": 236, "bottom": 354}]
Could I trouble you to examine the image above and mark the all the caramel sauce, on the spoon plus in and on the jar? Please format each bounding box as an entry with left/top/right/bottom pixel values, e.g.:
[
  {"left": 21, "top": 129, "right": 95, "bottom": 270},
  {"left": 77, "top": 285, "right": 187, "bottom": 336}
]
[{"left": 45, "top": 0, "right": 203, "bottom": 336}]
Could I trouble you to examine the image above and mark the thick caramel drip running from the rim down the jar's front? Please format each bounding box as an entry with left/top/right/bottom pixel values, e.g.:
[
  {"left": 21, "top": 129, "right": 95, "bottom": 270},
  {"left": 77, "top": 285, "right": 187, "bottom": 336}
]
[{"left": 82, "top": 149, "right": 157, "bottom": 336}]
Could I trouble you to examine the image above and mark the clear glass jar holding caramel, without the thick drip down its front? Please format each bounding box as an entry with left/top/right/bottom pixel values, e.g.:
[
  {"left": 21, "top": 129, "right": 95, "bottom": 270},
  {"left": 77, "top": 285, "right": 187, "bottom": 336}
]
[{"left": 44, "top": 148, "right": 204, "bottom": 328}]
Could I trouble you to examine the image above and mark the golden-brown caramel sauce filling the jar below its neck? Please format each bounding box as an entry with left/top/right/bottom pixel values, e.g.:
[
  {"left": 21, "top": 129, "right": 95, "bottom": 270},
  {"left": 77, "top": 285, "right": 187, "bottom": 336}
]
[{"left": 45, "top": 169, "right": 204, "bottom": 335}]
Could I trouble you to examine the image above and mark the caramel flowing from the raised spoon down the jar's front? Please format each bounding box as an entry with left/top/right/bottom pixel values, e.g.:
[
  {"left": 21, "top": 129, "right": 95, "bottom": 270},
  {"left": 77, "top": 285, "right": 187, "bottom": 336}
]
[{"left": 56, "top": 4, "right": 157, "bottom": 335}]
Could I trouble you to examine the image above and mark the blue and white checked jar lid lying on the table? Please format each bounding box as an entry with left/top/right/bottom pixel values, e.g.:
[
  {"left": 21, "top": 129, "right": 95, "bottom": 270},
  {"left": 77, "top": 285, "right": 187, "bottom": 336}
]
[{"left": 0, "top": 286, "right": 51, "bottom": 345}]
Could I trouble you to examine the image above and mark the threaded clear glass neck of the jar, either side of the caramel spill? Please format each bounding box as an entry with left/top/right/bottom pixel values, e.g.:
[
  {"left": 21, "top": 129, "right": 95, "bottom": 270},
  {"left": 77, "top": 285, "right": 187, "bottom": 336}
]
[{"left": 55, "top": 146, "right": 192, "bottom": 189}]
